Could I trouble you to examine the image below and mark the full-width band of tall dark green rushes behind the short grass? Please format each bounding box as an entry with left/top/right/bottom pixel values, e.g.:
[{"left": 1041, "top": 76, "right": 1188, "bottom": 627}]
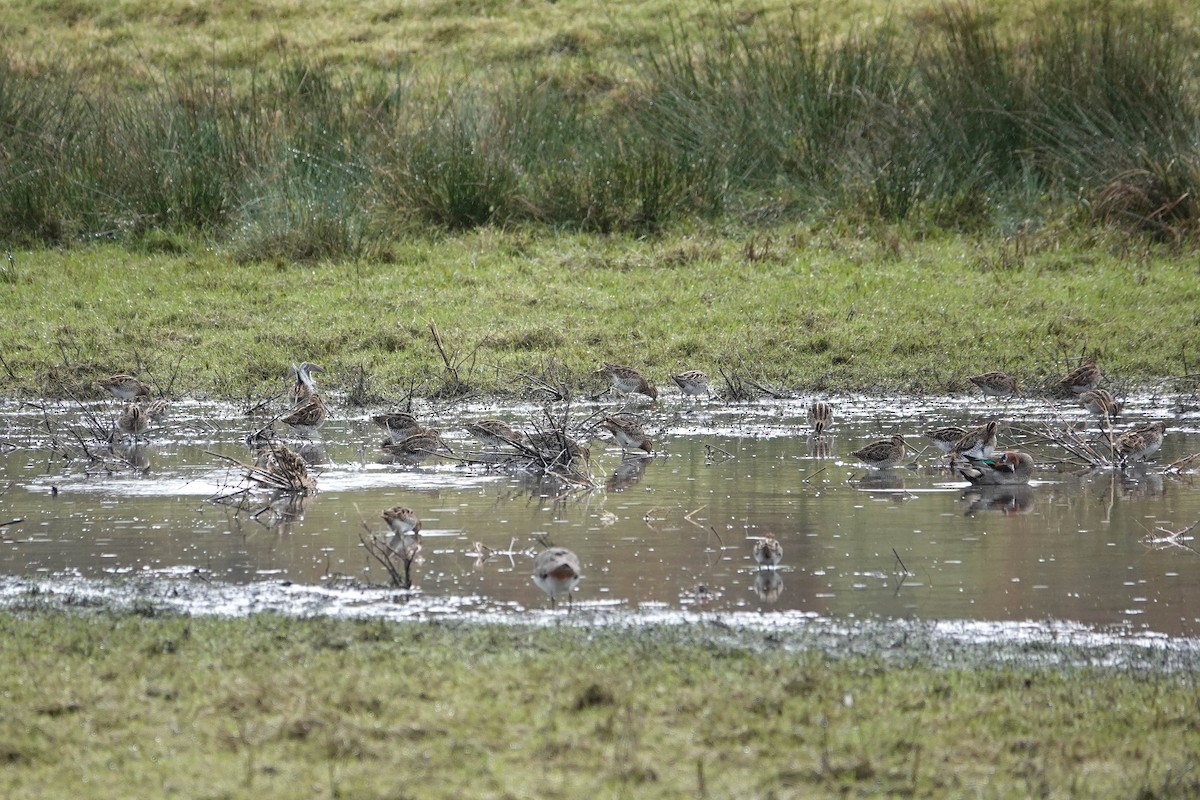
[{"left": 0, "top": 2, "right": 1200, "bottom": 250}]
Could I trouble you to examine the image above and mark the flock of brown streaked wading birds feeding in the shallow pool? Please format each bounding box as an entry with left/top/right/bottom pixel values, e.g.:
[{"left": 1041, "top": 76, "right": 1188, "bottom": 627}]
[{"left": 96, "top": 359, "right": 1166, "bottom": 604}]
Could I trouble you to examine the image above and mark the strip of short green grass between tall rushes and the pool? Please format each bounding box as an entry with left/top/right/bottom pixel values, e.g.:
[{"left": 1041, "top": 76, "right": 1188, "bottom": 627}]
[{"left": 0, "top": 225, "right": 1200, "bottom": 407}]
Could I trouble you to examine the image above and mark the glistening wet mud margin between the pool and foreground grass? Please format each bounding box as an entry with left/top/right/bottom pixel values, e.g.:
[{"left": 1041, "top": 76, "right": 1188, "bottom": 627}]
[{"left": 0, "top": 577, "right": 1200, "bottom": 673}]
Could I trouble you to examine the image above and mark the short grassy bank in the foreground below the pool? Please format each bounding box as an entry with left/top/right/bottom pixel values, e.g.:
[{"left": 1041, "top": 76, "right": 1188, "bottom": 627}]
[{"left": 0, "top": 612, "right": 1200, "bottom": 800}]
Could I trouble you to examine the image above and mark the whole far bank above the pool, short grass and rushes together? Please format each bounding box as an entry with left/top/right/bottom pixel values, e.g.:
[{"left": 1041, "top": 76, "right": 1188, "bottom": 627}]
[{"left": 7, "top": 0, "right": 1200, "bottom": 402}]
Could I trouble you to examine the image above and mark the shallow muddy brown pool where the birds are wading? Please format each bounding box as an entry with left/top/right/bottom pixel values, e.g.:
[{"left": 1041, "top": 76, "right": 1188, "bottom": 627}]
[{"left": 0, "top": 397, "right": 1200, "bottom": 637}]
